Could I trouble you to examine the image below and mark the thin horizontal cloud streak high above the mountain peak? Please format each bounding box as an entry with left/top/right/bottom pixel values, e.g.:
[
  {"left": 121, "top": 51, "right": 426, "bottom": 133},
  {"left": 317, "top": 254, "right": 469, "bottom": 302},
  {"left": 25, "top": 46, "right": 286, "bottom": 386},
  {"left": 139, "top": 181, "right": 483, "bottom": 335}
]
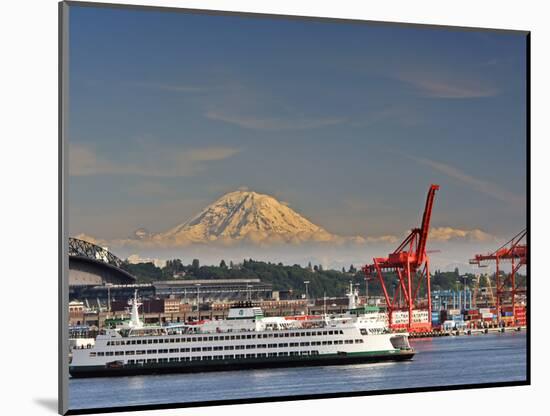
[{"left": 206, "top": 111, "right": 345, "bottom": 130}]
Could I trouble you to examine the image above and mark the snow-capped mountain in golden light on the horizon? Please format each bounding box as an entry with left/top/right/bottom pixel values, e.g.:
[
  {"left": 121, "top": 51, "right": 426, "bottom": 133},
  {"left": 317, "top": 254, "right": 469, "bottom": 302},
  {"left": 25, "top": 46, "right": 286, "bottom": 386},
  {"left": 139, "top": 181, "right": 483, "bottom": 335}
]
[{"left": 150, "top": 191, "right": 338, "bottom": 245}]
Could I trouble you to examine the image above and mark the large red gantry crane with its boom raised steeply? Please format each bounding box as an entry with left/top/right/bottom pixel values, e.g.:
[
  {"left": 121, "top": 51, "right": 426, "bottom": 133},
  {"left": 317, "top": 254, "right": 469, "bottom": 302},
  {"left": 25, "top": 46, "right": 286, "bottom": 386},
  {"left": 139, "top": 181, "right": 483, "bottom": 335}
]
[{"left": 363, "top": 184, "right": 439, "bottom": 332}]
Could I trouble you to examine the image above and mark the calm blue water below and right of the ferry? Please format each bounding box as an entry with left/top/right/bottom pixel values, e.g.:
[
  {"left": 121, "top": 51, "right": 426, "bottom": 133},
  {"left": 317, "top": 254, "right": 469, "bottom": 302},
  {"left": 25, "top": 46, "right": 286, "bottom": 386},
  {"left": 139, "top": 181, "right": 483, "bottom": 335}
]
[{"left": 69, "top": 332, "right": 526, "bottom": 409}]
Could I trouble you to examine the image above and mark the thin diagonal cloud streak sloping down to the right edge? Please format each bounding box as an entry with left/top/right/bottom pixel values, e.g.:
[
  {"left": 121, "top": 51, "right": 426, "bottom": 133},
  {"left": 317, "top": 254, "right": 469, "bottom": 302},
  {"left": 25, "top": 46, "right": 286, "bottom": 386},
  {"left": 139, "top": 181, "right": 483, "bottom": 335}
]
[{"left": 405, "top": 155, "right": 525, "bottom": 205}]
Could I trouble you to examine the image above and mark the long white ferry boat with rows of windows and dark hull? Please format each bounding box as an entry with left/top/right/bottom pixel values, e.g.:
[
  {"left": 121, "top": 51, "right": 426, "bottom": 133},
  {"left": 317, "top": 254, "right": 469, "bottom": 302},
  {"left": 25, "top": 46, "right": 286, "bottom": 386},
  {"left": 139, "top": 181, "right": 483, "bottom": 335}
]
[{"left": 69, "top": 292, "right": 414, "bottom": 377}]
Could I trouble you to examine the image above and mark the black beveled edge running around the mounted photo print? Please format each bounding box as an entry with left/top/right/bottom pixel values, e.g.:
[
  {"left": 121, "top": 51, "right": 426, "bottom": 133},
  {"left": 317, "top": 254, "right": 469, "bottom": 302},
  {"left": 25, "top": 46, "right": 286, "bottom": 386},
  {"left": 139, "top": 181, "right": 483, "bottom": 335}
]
[{"left": 58, "top": 1, "right": 531, "bottom": 415}]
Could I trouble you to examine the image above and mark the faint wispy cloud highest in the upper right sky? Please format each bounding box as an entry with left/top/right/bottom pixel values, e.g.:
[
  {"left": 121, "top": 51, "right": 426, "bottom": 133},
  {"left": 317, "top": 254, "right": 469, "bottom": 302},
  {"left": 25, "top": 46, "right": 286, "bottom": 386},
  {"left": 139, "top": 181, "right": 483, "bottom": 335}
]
[{"left": 396, "top": 71, "right": 499, "bottom": 99}]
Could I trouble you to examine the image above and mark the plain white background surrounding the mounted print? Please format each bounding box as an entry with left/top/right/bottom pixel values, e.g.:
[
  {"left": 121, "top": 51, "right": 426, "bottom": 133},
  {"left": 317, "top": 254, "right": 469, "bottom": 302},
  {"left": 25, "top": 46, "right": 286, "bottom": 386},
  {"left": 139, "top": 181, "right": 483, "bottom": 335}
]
[{"left": 0, "top": 0, "right": 550, "bottom": 416}]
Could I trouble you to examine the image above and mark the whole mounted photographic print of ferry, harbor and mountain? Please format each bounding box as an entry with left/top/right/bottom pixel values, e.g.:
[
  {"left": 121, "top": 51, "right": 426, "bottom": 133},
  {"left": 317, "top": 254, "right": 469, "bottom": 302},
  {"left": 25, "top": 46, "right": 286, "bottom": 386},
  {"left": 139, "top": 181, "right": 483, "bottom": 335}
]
[{"left": 59, "top": 2, "right": 530, "bottom": 414}]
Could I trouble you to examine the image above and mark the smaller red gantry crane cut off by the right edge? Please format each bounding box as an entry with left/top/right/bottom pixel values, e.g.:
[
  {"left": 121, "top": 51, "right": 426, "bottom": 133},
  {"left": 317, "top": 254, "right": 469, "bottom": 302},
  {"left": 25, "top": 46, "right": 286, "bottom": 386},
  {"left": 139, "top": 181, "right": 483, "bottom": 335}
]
[{"left": 470, "top": 229, "right": 527, "bottom": 320}]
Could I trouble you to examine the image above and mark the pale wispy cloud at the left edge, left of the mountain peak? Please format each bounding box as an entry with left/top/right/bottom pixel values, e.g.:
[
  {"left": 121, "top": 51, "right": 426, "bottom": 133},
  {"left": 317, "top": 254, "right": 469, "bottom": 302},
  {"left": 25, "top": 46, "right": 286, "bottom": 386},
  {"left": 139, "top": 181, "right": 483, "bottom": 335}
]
[{"left": 69, "top": 143, "right": 240, "bottom": 177}]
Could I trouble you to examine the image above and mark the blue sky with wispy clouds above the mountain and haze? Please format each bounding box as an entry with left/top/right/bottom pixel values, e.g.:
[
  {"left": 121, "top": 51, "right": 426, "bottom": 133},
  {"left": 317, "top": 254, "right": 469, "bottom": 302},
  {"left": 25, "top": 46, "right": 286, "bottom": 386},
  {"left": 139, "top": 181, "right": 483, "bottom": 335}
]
[{"left": 69, "top": 6, "right": 526, "bottom": 252}]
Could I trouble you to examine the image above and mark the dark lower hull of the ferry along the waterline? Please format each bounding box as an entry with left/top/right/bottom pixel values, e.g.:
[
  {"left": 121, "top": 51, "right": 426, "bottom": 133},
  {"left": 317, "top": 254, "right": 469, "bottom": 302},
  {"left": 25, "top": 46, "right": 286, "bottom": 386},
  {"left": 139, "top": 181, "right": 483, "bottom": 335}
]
[{"left": 69, "top": 350, "right": 415, "bottom": 378}]
